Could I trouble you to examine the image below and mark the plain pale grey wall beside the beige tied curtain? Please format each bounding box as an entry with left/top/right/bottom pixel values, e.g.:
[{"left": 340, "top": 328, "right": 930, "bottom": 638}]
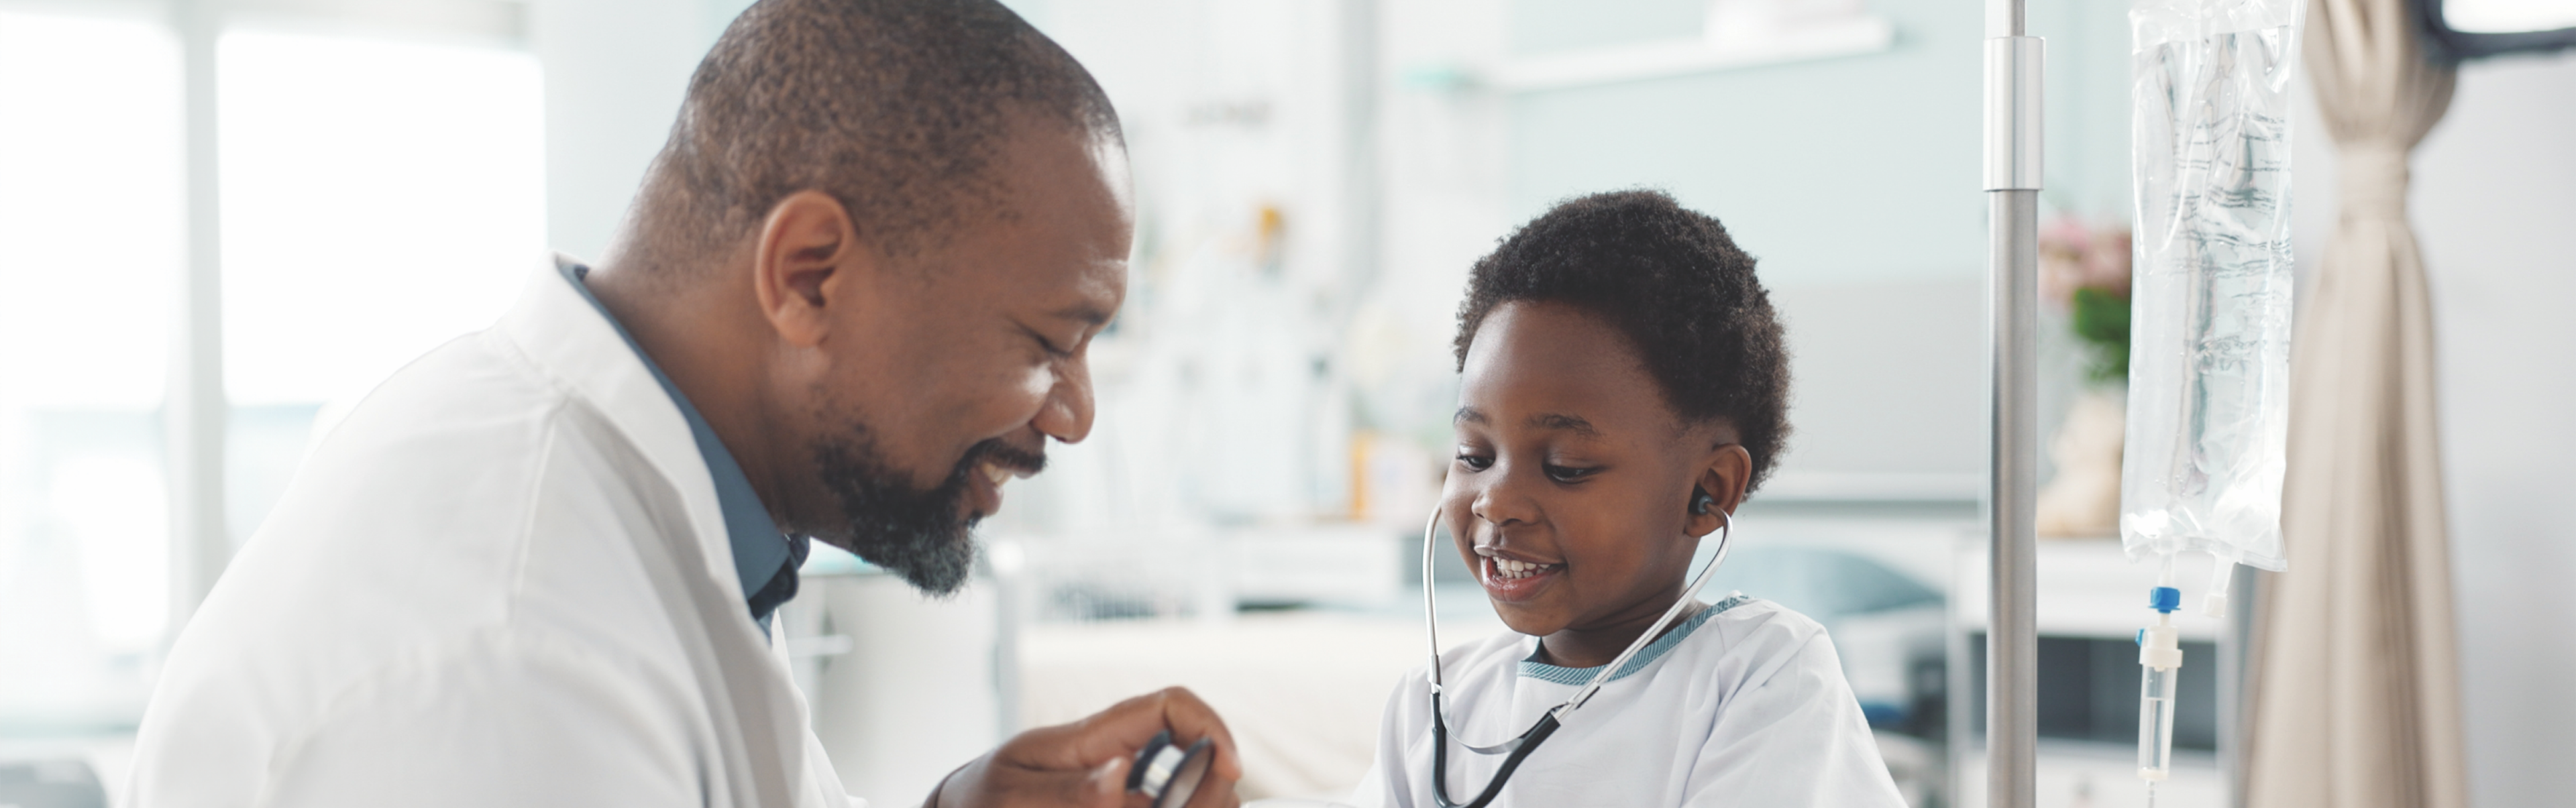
[{"left": 2295, "top": 54, "right": 2576, "bottom": 805}]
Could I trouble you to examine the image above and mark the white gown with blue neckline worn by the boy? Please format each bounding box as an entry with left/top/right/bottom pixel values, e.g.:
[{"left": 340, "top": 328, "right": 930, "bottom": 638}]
[{"left": 1352, "top": 594, "right": 1904, "bottom": 808}]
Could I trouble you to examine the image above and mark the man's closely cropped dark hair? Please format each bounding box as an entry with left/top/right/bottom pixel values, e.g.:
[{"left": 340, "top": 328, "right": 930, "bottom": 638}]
[{"left": 629, "top": 0, "right": 1120, "bottom": 265}]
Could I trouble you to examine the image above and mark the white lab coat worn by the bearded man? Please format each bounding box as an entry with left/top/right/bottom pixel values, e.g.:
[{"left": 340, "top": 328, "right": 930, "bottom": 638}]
[{"left": 131, "top": 265, "right": 853, "bottom": 808}]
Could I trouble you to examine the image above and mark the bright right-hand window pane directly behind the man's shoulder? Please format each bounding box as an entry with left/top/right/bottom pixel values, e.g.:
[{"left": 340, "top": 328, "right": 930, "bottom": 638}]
[{"left": 217, "top": 31, "right": 546, "bottom": 406}]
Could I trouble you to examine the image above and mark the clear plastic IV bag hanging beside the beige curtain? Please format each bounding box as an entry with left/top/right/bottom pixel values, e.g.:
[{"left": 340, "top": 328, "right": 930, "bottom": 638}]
[{"left": 2120, "top": 0, "right": 2306, "bottom": 571}]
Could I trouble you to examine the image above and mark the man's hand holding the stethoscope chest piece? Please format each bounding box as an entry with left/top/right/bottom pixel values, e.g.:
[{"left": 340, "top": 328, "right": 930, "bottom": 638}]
[{"left": 930, "top": 687, "right": 1244, "bottom": 808}]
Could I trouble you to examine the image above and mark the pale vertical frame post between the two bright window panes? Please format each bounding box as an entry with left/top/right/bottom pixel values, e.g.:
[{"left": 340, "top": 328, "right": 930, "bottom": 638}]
[{"left": 162, "top": 0, "right": 232, "bottom": 641}]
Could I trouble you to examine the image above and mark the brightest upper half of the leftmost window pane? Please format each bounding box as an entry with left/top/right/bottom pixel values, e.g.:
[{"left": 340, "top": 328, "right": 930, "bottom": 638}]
[{"left": 0, "top": 13, "right": 185, "bottom": 409}]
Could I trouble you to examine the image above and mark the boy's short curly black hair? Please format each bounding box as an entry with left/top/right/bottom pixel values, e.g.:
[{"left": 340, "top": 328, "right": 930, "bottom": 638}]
[{"left": 1456, "top": 190, "right": 1788, "bottom": 494}]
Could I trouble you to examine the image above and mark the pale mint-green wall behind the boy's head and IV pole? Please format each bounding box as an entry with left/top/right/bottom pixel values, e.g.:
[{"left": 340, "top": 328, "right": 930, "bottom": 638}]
[{"left": 1507, "top": 0, "right": 2128, "bottom": 491}]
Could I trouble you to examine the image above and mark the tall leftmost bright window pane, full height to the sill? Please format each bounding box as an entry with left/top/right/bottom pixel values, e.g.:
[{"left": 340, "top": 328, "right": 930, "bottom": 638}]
[{"left": 0, "top": 13, "right": 185, "bottom": 720}]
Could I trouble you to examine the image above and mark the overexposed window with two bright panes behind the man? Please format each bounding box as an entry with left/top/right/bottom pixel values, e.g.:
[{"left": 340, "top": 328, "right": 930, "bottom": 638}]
[{"left": 0, "top": 8, "right": 543, "bottom": 734}]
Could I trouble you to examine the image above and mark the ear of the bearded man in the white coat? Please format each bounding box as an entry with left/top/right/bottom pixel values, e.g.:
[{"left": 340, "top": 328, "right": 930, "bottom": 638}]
[{"left": 752, "top": 190, "right": 878, "bottom": 347}]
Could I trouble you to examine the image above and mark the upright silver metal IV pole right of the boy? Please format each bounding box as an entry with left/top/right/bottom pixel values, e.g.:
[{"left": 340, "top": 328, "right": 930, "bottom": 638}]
[{"left": 1984, "top": 0, "right": 2045, "bottom": 808}]
